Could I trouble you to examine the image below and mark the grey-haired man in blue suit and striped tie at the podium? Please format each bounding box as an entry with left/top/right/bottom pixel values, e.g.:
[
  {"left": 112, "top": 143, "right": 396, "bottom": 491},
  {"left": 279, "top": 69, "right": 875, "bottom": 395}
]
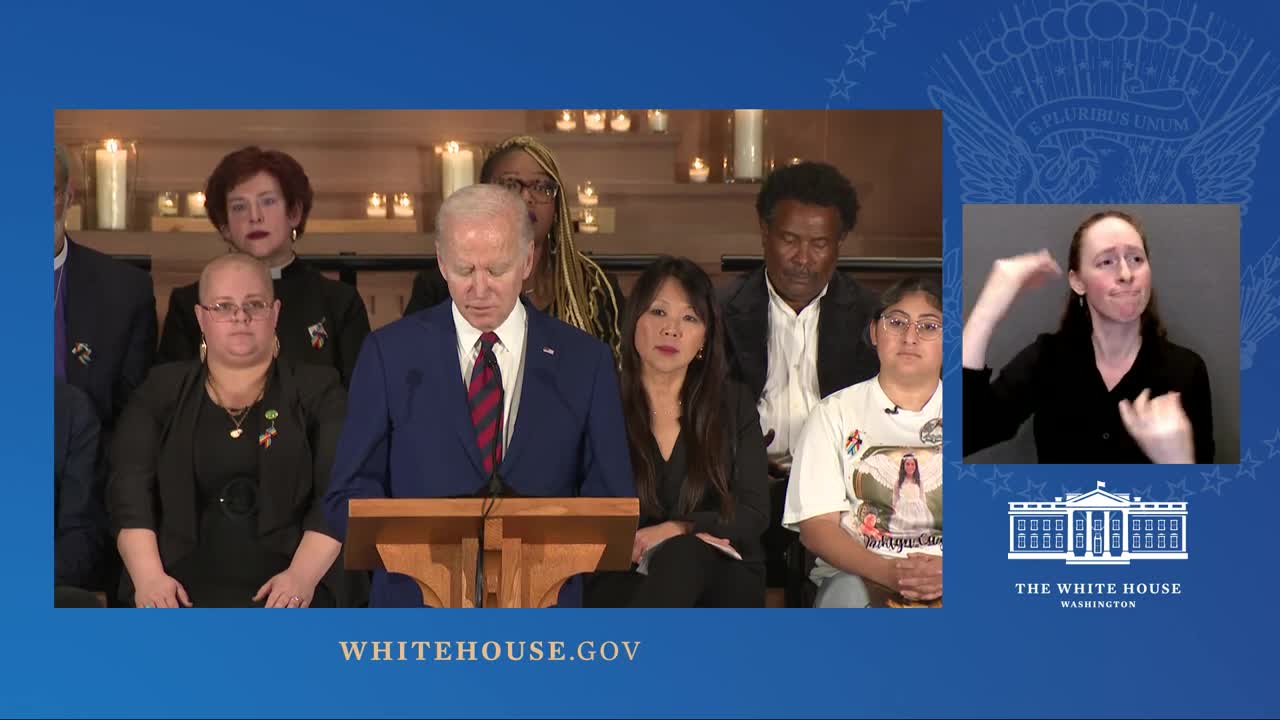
[{"left": 325, "top": 184, "right": 635, "bottom": 607}]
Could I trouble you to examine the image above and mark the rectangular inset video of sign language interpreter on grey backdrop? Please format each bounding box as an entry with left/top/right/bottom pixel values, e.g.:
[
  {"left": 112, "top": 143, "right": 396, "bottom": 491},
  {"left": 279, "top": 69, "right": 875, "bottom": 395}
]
[{"left": 961, "top": 205, "right": 1239, "bottom": 464}]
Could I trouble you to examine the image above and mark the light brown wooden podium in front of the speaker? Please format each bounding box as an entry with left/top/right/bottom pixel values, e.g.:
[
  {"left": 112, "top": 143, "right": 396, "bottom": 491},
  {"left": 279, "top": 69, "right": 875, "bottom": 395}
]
[{"left": 346, "top": 497, "right": 640, "bottom": 607}]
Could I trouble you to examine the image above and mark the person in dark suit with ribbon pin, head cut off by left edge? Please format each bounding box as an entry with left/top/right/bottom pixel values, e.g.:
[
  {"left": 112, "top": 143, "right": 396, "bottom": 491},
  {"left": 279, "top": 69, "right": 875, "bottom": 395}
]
[{"left": 54, "top": 146, "right": 156, "bottom": 430}]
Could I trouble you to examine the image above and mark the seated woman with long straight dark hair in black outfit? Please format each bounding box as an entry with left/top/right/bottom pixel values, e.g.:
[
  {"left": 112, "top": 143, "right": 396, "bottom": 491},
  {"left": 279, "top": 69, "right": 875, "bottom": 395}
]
[{"left": 586, "top": 258, "right": 769, "bottom": 607}]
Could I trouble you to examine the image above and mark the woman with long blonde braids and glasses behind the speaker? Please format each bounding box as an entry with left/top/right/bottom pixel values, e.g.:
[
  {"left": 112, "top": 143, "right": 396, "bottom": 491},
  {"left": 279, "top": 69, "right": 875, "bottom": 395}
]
[{"left": 404, "top": 136, "right": 622, "bottom": 359}]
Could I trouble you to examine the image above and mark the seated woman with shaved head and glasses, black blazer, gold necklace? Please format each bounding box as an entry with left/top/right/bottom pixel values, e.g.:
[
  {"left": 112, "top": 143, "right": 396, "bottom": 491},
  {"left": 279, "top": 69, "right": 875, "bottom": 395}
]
[{"left": 108, "top": 254, "right": 346, "bottom": 607}]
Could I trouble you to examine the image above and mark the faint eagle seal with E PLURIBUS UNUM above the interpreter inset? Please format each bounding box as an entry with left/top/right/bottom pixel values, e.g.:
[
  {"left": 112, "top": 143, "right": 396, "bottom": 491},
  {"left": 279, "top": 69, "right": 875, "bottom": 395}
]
[{"left": 928, "top": 0, "right": 1280, "bottom": 205}]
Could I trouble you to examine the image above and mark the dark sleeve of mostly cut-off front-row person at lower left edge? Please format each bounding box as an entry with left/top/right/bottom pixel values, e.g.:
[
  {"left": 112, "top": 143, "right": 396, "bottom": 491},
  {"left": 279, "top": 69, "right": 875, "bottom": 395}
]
[{"left": 54, "top": 383, "right": 106, "bottom": 588}]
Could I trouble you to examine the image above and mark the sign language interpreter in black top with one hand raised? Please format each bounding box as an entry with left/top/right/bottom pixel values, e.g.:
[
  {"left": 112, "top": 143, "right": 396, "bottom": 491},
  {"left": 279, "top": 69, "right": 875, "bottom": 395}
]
[{"left": 963, "top": 210, "right": 1213, "bottom": 462}]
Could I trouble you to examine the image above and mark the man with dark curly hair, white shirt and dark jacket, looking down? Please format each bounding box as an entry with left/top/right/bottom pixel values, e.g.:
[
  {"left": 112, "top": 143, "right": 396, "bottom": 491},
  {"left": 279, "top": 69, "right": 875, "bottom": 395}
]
[{"left": 722, "top": 163, "right": 879, "bottom": 594}]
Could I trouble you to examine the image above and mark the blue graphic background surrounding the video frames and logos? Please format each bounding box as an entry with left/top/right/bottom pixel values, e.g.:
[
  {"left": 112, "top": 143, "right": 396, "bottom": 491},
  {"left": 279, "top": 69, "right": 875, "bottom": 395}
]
[{"left": 10, "top": 0, "right": 1280, "bottom": 717}]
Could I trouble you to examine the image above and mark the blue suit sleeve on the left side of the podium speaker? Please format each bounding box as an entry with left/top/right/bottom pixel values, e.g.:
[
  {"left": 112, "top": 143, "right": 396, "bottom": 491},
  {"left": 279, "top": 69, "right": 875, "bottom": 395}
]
[{"left": 324, "top": 334, "right": 392, "bottom": 539}]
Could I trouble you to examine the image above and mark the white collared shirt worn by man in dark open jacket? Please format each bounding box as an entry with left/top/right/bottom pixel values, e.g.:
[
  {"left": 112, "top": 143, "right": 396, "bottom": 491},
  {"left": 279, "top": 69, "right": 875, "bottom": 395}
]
[{"left": 756, "top": 274, "right": 829, "bottom": 457}]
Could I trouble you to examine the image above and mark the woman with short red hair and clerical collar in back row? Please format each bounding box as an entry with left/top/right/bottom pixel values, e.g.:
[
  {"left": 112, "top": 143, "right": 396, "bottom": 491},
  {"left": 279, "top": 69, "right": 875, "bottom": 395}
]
[{"left": 157, "top": 147, "right": 369, "bottom": 386}]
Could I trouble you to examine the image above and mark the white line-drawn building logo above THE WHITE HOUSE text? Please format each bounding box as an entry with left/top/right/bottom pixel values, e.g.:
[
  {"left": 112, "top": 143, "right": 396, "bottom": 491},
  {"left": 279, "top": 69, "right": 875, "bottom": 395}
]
[{"left": 1009, "top": 482, "right": 1187, "bottom": 565}]
